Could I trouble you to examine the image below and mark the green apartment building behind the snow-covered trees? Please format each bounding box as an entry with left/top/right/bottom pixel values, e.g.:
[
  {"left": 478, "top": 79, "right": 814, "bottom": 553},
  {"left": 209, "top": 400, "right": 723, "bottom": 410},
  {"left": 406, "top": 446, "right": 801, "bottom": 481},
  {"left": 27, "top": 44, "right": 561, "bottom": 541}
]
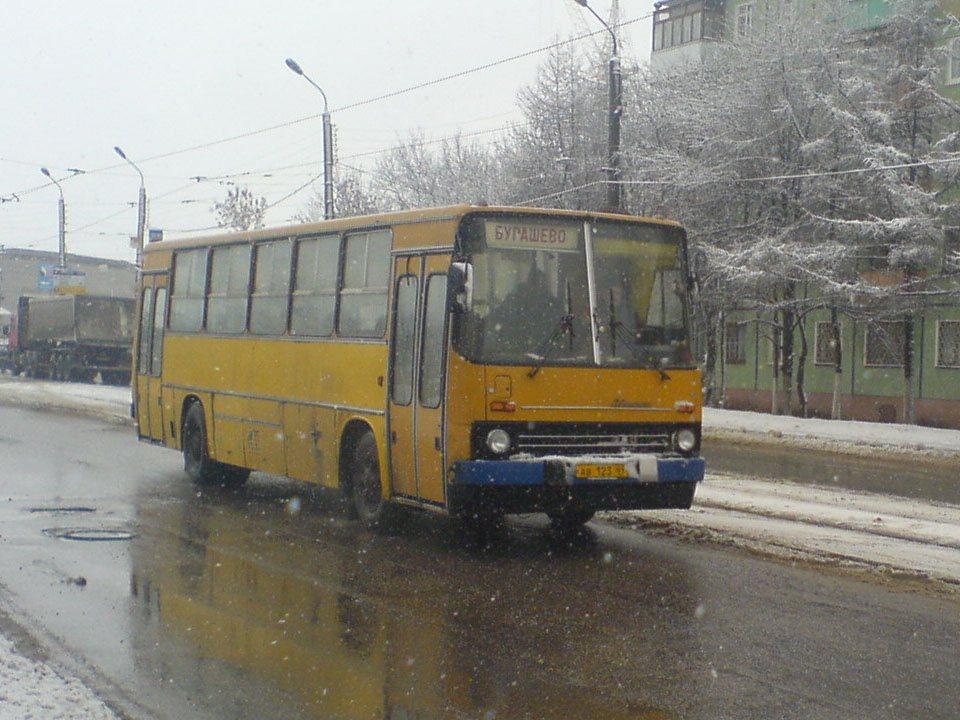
[{"left": 650, "top": 0, "right": 960, "bottom": 428}]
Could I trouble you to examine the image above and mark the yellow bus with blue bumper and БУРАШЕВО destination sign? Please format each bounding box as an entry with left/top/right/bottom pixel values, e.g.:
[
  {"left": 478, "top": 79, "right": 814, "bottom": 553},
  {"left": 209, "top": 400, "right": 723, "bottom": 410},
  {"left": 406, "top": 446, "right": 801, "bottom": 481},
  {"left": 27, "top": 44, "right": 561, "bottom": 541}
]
[{"left": 133, "top": 205, "right": 704, "bottom": 529}]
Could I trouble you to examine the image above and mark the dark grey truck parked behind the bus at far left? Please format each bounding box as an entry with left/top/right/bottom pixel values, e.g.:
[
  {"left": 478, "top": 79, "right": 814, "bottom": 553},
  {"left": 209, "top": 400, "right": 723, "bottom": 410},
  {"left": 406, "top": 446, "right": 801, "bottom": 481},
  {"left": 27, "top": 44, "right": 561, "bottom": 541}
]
[{"left": 0, "top": 295, "right": 134, "bottom": 385}]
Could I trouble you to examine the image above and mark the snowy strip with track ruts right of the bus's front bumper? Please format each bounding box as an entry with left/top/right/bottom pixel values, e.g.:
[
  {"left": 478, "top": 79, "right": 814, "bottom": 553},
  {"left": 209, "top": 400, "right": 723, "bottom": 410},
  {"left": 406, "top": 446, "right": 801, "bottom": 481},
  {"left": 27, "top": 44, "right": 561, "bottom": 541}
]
[{"left": 604, "top": 474, "right": 960, "bottom": 591}]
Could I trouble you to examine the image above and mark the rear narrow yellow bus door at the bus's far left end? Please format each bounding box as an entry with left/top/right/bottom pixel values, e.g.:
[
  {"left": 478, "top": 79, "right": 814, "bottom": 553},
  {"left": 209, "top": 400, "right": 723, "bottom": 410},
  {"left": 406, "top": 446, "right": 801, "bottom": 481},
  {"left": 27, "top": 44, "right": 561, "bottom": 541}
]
[{"left": 134, "top": 275, "right": 167, "bottom": 442}]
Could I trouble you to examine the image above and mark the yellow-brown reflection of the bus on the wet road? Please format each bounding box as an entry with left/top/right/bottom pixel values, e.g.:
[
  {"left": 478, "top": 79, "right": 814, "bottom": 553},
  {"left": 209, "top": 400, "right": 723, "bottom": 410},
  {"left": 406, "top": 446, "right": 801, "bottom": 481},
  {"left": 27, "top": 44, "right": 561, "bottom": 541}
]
[{"left": 131, "top": 491, "right": 692, "bottom": 720}]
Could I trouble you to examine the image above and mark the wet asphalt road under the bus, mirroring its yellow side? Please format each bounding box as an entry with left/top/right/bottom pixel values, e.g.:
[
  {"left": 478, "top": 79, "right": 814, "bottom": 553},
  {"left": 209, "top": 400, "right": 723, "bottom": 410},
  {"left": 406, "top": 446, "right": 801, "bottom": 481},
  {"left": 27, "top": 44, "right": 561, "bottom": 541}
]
[{"left": 0, "top": 407, "right": 960, "bottom": 720}]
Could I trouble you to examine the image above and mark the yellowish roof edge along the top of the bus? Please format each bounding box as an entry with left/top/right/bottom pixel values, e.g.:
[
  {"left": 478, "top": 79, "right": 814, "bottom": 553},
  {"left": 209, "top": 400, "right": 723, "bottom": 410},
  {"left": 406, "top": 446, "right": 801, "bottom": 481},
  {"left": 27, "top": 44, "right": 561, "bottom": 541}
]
[{"left": 144, "top": 204, "right": 680, "bottom": 252}]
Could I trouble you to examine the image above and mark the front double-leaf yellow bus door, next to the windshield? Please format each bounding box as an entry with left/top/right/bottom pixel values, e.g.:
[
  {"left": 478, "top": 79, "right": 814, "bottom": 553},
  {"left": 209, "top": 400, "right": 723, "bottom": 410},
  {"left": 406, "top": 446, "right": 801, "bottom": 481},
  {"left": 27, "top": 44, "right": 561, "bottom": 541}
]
[{"left": 389, "top": 255, "right": 449, "bottom": 504}]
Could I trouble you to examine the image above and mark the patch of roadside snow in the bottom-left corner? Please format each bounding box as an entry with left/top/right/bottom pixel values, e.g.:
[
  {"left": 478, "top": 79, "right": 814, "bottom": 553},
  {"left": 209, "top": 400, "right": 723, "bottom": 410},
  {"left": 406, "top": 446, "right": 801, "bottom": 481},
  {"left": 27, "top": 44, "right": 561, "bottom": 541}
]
[{"left": 0, "top": 635, "right": 117, "bottom": 720}]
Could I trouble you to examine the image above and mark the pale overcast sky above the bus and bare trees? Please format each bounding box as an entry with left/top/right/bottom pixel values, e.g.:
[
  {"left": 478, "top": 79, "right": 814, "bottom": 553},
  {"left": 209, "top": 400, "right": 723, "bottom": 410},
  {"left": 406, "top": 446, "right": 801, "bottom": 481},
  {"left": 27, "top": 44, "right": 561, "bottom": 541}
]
[{"left": 0, "top": 0, "right": 653, "bottom": 261}]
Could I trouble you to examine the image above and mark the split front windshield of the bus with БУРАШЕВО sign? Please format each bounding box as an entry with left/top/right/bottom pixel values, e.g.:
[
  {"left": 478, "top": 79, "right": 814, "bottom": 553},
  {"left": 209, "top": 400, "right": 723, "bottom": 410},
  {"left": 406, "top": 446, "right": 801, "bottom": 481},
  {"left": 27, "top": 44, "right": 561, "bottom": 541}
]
[{"left": 454, "top": 216, "right": 692, "bottom": 369}]
